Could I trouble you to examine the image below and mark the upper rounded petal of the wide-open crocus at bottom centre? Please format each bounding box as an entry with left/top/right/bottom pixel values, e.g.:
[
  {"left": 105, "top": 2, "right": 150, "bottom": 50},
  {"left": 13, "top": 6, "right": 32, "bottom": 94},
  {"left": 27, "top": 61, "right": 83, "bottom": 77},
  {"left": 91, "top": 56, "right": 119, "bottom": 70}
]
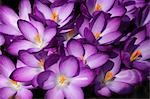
[{"left": 59, "top": 56, "right": 79, "bottom": 77}]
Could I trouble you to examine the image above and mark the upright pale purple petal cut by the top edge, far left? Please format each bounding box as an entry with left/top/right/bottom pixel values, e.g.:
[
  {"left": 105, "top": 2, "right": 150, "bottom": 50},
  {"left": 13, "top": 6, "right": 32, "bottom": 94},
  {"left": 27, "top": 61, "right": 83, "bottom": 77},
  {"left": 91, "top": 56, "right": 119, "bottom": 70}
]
[{"left": 19, "top": 0, "right": 31, "bottom": 20}]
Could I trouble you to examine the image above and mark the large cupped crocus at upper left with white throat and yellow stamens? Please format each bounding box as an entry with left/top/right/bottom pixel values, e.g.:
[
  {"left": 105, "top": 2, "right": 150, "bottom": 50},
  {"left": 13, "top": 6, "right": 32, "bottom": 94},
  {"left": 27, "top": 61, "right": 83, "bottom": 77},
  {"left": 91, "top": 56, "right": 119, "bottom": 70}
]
[{"left": 7, "top": 20, "right": 56, "bottom": 55}]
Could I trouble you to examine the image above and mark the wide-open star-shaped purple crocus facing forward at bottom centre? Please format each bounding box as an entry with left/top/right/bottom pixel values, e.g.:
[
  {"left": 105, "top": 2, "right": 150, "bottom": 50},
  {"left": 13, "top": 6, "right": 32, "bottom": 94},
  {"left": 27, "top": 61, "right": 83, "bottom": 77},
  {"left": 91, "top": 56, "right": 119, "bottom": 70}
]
[{"left": 38, "top": 56, "right": 94, "bottom": 99}]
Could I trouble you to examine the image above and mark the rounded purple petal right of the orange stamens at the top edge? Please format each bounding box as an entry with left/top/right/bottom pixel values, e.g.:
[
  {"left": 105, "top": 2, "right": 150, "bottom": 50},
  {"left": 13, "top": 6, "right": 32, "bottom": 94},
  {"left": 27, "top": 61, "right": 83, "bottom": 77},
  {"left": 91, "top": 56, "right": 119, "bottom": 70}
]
[{"left": 109, "top": 6, "right": 126, "bottom": 17}]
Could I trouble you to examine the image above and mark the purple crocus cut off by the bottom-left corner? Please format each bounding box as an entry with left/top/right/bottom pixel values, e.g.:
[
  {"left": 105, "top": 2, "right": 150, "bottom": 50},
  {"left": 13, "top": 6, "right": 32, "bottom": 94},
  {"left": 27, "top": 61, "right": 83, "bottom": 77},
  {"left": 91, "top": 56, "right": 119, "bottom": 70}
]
[{"left": 0, "top": 55, "right": 32, "bottom": 99}]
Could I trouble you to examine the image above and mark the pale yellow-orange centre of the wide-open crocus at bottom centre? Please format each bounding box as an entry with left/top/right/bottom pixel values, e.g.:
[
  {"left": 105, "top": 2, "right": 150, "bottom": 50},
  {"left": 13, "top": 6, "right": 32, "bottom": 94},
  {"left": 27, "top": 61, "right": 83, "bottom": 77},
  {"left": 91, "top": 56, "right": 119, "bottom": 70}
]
[{"left": 57, "top": 75, "right": 69, "bottom": 86}]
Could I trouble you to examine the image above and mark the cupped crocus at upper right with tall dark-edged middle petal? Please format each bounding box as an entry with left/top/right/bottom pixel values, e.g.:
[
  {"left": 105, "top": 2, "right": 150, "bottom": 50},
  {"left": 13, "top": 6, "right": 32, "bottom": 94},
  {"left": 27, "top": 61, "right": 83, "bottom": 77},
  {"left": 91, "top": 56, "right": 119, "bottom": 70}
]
[{"left": 81, "top": 12, "right": 121, "bottom": 44}]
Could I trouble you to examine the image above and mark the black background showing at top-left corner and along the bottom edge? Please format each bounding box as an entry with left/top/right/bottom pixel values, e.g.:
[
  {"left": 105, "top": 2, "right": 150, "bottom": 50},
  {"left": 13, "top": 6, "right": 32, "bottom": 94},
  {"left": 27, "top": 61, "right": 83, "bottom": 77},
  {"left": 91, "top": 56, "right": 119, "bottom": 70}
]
[{"left": 0, "top": 0, "right": 150, "bottom": 99}]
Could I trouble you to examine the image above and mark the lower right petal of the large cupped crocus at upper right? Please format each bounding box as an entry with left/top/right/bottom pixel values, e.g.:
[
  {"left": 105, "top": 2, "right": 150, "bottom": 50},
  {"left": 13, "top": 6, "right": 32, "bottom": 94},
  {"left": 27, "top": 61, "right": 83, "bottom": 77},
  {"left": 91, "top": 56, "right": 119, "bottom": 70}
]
[{"left": 98, "top": 31, "right": 121, "bottom": 44}]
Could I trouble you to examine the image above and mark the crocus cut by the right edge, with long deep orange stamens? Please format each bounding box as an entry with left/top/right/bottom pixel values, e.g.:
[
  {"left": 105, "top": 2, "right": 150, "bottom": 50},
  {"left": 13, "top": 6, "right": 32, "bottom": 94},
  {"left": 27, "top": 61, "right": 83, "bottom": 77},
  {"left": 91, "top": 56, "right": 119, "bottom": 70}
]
[{"left": 122, "top": 40, "right": 150, "bottom": 72}]
